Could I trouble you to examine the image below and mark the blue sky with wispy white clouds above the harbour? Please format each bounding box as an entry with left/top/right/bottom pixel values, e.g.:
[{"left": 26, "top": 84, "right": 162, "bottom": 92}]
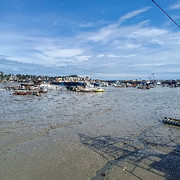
[{"left": 0, "top": 0, "right": 180, "bottom": 80}]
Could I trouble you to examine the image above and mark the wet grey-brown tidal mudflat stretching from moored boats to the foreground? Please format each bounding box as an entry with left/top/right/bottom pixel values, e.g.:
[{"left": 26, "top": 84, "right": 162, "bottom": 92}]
[{"left": 0, "top": 84, "right": 180, "bottom": 180}]
